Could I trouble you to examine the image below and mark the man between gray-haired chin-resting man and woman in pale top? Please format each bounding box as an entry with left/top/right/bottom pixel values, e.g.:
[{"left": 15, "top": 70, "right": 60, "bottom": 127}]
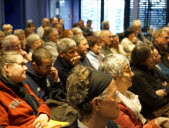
[{"left": 73, "top": 35, "right": 92, "bottom": 67}]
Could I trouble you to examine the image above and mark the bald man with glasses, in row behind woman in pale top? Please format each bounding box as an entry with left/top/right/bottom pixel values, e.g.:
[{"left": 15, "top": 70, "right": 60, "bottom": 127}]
[{"left": 99, "top": 30, "right": 113, "bottom": 56}]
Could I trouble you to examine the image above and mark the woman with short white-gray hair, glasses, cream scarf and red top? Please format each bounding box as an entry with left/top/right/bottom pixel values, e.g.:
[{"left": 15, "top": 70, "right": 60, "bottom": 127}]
[{"left": 99, "top": 54, "right": 169, "bottom": 128}]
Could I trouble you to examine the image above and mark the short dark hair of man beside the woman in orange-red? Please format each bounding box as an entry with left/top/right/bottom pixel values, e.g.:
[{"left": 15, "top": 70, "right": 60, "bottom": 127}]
[{"left": 32, "top": 47, "right": 52, "bottom": 65}]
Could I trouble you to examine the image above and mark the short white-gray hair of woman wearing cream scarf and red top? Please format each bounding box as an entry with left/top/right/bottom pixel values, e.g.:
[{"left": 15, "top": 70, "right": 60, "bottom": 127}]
[{"left": 98, "top": 54, "right": 130, "bottom": 76}]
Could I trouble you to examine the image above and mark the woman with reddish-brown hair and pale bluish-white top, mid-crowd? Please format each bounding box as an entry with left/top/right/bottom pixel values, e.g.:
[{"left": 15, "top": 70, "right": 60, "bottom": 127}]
[{"left": 86, "top": 36, "right": 104, "bottom": 70}]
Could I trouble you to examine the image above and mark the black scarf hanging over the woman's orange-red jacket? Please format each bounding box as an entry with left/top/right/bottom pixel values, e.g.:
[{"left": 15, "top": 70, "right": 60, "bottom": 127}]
[{"left": 0, "top": 73, "right": 39, "bottom": 115}]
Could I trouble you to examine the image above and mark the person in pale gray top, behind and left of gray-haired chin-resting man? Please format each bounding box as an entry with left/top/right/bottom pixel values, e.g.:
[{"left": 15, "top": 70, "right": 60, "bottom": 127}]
[{"left": 44, "top": 28, "right": 59, "bottom": 62}]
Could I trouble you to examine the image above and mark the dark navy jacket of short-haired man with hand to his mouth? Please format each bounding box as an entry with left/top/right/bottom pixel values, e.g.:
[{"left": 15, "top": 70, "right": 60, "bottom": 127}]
[{"left": 23, "top": 61, "right": 63, "bottom": 101}]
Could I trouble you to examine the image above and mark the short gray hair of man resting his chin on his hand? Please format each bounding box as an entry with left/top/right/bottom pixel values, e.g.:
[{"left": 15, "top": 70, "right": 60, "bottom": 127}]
[{"left": 57, "top": 38, "right": 76, "bottom": 52}]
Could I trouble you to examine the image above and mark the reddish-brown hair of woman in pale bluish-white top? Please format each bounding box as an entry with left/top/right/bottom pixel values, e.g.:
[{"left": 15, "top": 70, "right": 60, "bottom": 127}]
[{"left": 87, "top": 36, "right": 101, "bottom": 47}]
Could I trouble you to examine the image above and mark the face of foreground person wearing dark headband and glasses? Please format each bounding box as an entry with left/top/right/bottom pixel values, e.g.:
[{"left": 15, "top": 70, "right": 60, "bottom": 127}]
[{"left": 98, "top": 80, "right": 120, "bottom": 121}]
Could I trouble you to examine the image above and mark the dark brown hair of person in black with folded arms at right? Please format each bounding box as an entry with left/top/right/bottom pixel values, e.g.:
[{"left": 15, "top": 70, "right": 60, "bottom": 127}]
[{"left": 131, "top": 45, "right": 151, "bottom": 65}]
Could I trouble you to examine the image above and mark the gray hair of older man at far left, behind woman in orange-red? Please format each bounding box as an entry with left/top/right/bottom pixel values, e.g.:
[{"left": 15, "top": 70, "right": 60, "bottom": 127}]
[{"left": 2, "top": 35, "right": 19, "bottom": 48}]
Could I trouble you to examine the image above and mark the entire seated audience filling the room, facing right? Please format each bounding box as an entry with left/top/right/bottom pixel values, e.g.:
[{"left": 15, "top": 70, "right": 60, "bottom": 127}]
[{"left": 0, "top": 17, "right": 169, "bottom": 128}]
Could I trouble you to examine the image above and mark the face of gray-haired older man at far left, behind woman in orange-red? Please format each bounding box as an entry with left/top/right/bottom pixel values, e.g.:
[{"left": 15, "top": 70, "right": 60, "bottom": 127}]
[{"left": 7, "top": 38, "right": 21, "bottom": 51}]
